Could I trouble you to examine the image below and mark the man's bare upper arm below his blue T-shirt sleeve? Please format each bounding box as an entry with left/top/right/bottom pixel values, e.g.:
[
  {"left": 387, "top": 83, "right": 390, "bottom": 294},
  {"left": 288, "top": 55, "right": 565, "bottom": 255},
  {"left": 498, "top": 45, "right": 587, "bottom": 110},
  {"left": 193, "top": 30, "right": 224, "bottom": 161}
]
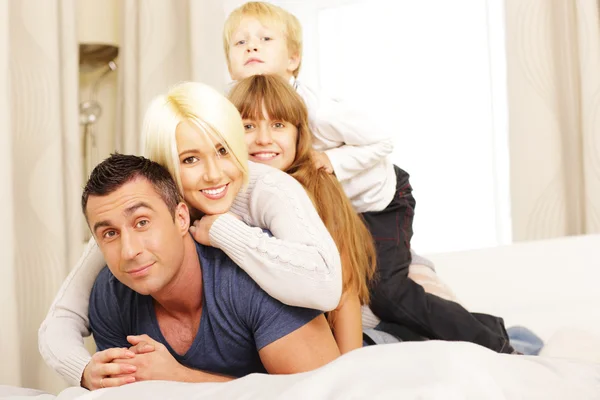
[{"left": 258, "top": 315, "right": 340, "bottom": 374}]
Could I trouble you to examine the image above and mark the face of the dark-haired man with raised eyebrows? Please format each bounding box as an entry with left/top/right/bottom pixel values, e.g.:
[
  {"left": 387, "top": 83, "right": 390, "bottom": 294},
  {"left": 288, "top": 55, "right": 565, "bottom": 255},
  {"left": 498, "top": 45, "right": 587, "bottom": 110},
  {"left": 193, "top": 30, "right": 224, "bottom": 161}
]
[{"left": 86, "top": 177, "right": 189, "bottom": 295}]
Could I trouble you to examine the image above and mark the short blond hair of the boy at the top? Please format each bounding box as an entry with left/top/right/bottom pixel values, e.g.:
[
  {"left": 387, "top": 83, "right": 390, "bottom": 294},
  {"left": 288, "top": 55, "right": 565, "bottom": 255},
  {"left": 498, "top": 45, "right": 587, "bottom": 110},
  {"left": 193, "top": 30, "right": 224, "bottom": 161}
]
[{"left": 223, "top": 1, "right": 302, "bottom": 78}]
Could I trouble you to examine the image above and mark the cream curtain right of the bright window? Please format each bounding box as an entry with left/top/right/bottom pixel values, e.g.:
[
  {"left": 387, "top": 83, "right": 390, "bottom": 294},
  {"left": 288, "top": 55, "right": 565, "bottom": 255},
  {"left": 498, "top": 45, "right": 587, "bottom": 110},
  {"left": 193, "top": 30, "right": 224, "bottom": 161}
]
[{"left": 506, "top": 0, "right": 600, "bottom": 240}]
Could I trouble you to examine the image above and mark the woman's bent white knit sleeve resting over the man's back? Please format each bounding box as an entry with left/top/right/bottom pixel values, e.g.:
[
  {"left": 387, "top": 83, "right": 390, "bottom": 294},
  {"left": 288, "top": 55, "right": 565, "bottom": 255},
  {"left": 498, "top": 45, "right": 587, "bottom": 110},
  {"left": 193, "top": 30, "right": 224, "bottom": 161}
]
[{"left": 209, "top": 168, "right": 342, "bottom": 311}]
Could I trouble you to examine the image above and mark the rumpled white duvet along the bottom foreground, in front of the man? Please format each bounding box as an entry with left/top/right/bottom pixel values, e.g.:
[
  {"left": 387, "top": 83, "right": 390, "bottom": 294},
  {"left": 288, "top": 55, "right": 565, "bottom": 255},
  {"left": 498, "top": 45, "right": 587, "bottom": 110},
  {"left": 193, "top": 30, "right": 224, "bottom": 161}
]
[{"left": 0, "top": 341, "right": 600, "bottom": 400}]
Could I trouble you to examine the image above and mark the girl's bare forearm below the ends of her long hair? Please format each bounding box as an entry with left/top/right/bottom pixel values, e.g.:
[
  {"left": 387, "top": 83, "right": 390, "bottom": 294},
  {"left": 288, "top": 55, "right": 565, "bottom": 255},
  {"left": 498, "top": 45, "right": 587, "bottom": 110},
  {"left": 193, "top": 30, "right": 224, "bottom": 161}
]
[{"left": 331, "top": 291, "right": 363, "bottom": 354}]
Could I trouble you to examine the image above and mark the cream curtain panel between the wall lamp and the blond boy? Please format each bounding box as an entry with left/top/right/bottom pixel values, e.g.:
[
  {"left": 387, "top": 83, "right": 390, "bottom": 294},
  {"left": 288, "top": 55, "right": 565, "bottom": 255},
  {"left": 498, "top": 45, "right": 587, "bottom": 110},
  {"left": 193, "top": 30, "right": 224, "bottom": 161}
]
[{"left": 116, "top": 0, "right": 226, "bottom": 154}]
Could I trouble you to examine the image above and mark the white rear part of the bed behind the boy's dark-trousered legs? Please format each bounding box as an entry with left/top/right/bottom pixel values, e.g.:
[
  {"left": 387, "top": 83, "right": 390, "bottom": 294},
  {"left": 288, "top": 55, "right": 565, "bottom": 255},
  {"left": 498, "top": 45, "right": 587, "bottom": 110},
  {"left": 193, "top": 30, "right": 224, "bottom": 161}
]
[{"left": 428, "top": 235, "right": 600, "bottom": 362}]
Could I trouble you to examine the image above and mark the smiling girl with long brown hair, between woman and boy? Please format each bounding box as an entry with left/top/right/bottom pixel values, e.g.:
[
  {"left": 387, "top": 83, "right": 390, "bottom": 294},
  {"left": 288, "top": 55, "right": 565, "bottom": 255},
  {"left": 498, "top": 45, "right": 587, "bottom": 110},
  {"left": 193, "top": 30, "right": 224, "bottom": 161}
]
[{"left": 229, "top": 76, "right": 376, "bottom": 354}]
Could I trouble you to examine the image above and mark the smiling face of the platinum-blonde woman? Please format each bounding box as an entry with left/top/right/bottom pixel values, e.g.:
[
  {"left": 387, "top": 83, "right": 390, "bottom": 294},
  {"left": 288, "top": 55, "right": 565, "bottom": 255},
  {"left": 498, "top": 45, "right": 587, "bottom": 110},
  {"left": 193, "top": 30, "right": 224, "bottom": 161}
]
[{"left": 175, "top": 121, "right": 243, "bottom": 215}]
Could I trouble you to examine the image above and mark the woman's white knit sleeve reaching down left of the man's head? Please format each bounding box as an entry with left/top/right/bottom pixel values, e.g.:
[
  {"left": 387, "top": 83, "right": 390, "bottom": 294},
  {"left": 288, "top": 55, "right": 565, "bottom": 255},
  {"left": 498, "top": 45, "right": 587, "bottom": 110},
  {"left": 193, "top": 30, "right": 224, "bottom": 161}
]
[{"left": 38, "top": 238, "right": 106, "bottom": 386}]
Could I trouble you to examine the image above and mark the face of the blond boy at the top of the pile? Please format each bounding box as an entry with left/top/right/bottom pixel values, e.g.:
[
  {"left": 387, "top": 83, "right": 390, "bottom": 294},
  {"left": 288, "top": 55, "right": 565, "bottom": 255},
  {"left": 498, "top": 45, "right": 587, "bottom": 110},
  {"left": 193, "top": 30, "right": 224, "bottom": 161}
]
[{"left": 227, "top": 17, "right": 300, "bottom": 81}]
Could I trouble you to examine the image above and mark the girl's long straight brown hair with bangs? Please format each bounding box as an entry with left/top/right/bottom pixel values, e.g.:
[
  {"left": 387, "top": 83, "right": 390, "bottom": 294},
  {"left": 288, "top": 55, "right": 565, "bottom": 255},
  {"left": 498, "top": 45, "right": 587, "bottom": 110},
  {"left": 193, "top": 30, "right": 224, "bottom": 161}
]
[{"left": 229, "top": 75, "right": 376, "bottom": 304}]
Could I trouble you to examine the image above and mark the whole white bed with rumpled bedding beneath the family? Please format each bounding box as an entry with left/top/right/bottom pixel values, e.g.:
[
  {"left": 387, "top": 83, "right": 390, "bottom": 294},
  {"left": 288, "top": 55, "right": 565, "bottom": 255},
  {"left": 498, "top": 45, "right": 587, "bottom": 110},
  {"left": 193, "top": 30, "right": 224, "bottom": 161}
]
[{"left": 0, "top": 235, "right": 600, "bottom": 400}]
